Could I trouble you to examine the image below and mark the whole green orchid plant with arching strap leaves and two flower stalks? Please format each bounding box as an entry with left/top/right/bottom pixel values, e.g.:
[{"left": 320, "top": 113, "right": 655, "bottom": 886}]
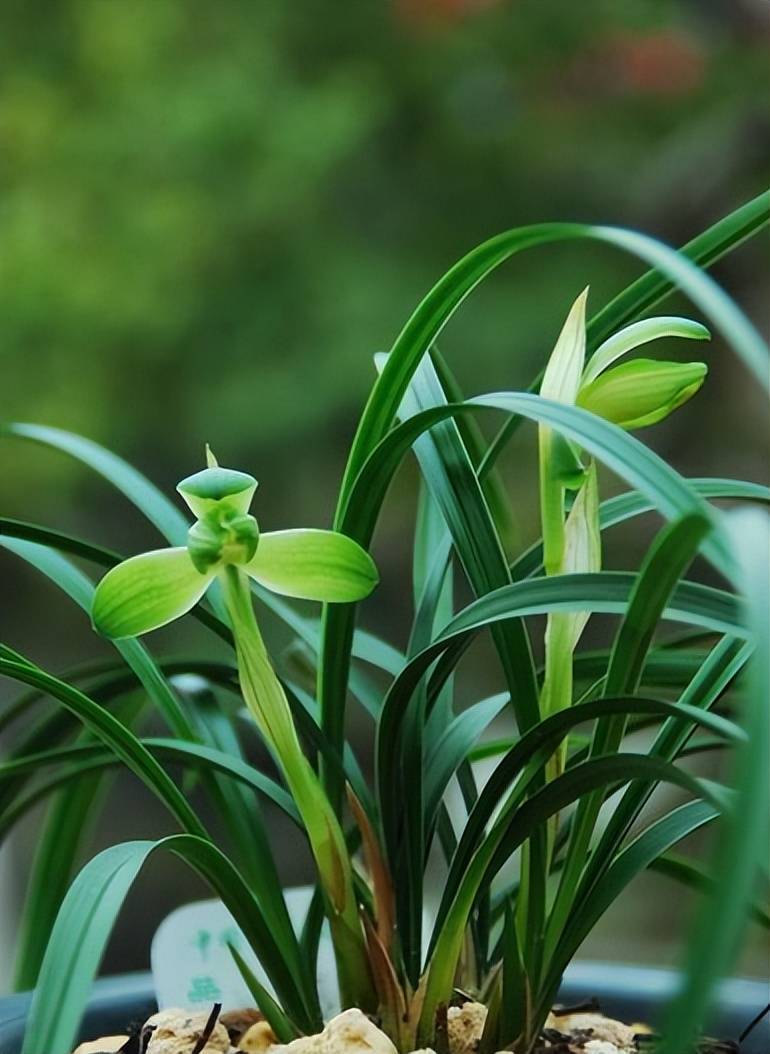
[{"left": 0, "top": 196, "right": 770, "bottom": 1054}]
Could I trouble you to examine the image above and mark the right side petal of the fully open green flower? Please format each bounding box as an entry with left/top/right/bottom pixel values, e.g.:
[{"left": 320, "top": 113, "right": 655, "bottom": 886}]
[{"left": 243, "top": 528, "right": 379, "bottom": 603}]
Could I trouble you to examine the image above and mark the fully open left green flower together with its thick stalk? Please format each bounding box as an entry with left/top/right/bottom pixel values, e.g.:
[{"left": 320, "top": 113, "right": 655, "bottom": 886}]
[{"left": 93, "top": 452, "right": 378, "bottom": 1010}]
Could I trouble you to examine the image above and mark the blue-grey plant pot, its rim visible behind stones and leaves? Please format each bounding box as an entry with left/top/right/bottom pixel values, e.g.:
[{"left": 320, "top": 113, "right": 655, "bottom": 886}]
[{"left": 0, "top": 962, "right": 770, "bottom": 1054}]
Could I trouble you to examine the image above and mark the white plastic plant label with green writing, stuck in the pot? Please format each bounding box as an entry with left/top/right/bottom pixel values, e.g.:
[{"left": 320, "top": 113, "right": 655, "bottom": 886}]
[{"left": 151, "top": 886, "right": 338, "bottom": 1017}]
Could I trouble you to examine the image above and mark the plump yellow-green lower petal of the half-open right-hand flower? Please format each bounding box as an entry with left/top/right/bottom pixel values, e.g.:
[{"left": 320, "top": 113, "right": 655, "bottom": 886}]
[{"left": 577, "top": 358, "right": 707, "bottom": 428}]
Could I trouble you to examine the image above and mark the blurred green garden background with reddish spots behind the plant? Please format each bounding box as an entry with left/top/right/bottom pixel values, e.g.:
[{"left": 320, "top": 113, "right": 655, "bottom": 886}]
[{"left": 0, "top": 0, "right": 770, "bottom": 981}]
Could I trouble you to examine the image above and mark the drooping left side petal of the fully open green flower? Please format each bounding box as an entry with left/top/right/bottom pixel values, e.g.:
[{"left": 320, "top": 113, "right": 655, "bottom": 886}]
[{"left": 92, "top": 547, "right": 214, "bottom": 639}]
